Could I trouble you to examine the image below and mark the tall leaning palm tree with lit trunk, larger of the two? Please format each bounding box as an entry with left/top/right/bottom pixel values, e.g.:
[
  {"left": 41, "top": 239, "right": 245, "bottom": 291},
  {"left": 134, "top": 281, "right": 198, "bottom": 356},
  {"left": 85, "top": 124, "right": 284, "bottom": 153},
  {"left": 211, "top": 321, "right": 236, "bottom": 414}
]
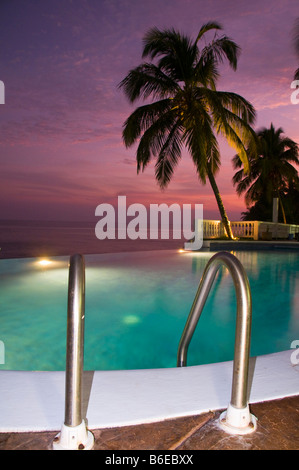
[{"left": 119, "top": 22, "right": 255, "bottom": 239}]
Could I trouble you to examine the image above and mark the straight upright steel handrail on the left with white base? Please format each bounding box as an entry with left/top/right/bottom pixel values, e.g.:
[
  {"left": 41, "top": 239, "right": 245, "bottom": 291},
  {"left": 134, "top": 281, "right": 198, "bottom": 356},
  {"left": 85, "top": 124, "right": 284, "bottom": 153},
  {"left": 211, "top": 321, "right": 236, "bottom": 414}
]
[{"left": 53, "top": 255, "right": 94, "bottom": 450}]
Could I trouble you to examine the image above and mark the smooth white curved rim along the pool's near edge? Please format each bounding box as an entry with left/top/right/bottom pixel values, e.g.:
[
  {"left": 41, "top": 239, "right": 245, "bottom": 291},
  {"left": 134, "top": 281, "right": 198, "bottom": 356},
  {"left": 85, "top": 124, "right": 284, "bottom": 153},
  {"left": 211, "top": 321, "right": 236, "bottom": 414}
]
[{"left": 0, "top": 350, "right": 299, "bottom": 432}]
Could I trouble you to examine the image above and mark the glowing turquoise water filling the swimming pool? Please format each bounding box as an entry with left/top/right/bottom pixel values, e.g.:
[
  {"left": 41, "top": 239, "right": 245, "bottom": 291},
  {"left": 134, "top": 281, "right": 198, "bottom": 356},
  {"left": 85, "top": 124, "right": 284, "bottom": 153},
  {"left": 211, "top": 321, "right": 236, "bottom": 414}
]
[{"left": 0, "top": 251, "right": 299, "bottom": 370}]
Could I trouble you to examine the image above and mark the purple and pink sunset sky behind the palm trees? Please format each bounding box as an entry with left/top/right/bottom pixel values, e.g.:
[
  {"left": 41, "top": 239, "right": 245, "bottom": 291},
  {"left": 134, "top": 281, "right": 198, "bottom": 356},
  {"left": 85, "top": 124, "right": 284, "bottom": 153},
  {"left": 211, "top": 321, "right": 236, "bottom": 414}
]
[{"left": 0, "top": 0, "right": 299, "bottom": 220}]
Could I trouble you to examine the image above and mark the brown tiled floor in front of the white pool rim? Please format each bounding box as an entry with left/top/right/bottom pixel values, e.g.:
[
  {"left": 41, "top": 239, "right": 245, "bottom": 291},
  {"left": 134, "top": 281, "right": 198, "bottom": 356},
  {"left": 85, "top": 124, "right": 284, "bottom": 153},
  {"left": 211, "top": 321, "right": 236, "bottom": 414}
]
[{"left": 0, "top": 395, "right": 299, "bottom": 451}]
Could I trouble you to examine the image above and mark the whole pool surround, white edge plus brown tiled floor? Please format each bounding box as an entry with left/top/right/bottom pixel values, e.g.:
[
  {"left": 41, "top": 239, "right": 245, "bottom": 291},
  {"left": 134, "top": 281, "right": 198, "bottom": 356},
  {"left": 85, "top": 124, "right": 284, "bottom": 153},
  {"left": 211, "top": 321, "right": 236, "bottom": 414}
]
[{"left": 0, "top": 350, "right": 299, "bottom": 451}]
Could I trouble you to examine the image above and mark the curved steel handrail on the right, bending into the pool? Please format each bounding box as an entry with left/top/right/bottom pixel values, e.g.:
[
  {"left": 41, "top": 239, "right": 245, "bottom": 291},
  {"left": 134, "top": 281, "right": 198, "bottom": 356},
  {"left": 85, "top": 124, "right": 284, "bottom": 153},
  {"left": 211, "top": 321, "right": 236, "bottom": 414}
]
[{"left": 177, "top": 252, "right": 256, "bottom": 434}]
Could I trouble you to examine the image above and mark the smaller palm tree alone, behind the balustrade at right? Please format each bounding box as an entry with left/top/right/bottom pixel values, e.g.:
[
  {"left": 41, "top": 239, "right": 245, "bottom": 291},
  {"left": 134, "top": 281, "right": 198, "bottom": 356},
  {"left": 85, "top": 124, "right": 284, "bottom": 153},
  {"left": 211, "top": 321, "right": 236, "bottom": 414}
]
[{"left": 233, "top": 124, "right": 299, "bottom": 223}]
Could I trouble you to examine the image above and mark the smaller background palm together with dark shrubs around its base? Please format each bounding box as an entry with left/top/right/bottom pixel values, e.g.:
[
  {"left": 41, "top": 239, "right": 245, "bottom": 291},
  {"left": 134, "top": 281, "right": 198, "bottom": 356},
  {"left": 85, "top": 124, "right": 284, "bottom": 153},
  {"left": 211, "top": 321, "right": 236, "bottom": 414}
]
[{"left": 233, "top": 124, "right": 299, "bottom": 223}]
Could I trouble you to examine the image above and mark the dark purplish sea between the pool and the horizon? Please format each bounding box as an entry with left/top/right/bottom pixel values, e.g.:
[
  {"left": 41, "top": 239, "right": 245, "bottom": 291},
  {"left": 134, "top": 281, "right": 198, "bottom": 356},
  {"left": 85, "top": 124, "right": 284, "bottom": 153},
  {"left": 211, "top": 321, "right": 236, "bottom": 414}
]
[{"left": 0, "top": 220, "right": 186, "bottom": 259}]
